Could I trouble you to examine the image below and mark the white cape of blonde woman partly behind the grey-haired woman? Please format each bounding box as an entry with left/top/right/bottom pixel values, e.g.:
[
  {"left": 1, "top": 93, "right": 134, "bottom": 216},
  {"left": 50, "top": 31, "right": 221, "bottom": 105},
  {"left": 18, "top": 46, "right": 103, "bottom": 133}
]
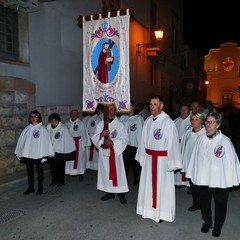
[{"left": 181, "top": 127, "right": 206, "bottom": 173}]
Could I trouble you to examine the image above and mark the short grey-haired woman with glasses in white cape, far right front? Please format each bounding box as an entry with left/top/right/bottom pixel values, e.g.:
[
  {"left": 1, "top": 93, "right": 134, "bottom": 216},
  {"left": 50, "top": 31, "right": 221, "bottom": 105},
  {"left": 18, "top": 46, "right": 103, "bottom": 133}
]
[{"left": 186, "top": 112, "right": 240, "bottom": 237}]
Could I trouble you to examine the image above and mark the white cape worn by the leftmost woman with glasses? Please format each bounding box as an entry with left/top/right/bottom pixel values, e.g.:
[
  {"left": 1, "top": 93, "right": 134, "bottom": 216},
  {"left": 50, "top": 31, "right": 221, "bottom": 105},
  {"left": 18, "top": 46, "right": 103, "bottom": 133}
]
[{"left": 14, "top": 123, "right": 54, "bottom": 159}]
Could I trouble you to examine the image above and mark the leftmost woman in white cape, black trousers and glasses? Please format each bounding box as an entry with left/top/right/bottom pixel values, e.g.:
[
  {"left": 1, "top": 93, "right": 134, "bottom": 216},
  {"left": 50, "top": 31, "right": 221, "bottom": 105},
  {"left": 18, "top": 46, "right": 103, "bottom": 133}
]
[{"left": 14, "top": 110, "right": 54, "bottom": 195}]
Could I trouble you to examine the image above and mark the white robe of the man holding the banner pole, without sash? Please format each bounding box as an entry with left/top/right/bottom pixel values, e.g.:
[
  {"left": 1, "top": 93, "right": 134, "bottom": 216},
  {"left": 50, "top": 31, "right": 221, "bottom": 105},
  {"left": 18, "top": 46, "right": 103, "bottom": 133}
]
[{"left": 92, "top": 117, "right": 129, "bottom": 193}]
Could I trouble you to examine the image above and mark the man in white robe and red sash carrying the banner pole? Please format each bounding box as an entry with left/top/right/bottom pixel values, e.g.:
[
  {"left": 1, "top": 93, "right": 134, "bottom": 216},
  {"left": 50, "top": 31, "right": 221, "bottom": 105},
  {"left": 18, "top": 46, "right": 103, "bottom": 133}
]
[{"left": 92, "top": 104, "right": 128, "bottom": 204}]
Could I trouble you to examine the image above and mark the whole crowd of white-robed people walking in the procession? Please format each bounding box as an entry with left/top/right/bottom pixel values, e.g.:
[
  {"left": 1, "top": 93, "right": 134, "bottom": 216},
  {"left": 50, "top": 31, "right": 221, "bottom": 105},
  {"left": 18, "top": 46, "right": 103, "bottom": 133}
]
[{"left": 15, "top": 96, "right": 240, "bottom": 237}]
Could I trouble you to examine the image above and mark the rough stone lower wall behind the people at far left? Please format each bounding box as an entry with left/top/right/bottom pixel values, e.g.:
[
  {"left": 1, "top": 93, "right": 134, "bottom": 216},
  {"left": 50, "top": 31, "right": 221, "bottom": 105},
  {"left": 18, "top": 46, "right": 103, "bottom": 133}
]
[{"left": 0, "top": 76, "right": 81, "bottom": 177}]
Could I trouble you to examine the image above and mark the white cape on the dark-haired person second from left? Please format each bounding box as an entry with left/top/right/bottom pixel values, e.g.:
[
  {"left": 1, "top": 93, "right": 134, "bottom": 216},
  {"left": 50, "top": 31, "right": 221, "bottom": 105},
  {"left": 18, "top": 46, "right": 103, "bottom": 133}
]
[{"left": 47, "top": 122, "right": 76, "bottom": 154}]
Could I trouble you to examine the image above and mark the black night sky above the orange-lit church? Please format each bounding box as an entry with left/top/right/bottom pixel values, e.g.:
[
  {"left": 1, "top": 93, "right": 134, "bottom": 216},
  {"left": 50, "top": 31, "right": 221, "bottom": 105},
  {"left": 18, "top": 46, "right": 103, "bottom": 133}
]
[{"left": 183, "top": 0, "right": 240, "bottom": 55}]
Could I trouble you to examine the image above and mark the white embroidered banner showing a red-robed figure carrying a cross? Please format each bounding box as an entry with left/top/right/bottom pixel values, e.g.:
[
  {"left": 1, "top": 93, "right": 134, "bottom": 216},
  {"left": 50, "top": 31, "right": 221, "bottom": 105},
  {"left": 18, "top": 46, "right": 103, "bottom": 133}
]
[{"left": 83, "top": 11, "right": 130, "bottom": 112}]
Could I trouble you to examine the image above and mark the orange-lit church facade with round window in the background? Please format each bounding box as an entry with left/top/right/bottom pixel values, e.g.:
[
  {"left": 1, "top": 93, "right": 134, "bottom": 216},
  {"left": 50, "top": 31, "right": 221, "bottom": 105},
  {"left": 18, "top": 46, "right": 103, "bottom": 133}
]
[{"left": 204, "top": 41, "right": 240, "bottom": 108}]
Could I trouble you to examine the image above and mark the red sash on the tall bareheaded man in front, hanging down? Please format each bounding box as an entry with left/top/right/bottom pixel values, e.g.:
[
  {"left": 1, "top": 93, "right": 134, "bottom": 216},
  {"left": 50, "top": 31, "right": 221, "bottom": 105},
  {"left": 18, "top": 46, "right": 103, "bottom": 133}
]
[{"left": 146, "top": 148, "right": 168, "bottom": 208}]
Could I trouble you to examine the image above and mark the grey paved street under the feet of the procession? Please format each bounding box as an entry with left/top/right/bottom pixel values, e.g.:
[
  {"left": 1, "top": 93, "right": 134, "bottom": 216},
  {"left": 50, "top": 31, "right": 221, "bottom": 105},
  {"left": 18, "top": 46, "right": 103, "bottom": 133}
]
[{"left": 0, "top": 169, "right": 240, "bottom": 240}]
